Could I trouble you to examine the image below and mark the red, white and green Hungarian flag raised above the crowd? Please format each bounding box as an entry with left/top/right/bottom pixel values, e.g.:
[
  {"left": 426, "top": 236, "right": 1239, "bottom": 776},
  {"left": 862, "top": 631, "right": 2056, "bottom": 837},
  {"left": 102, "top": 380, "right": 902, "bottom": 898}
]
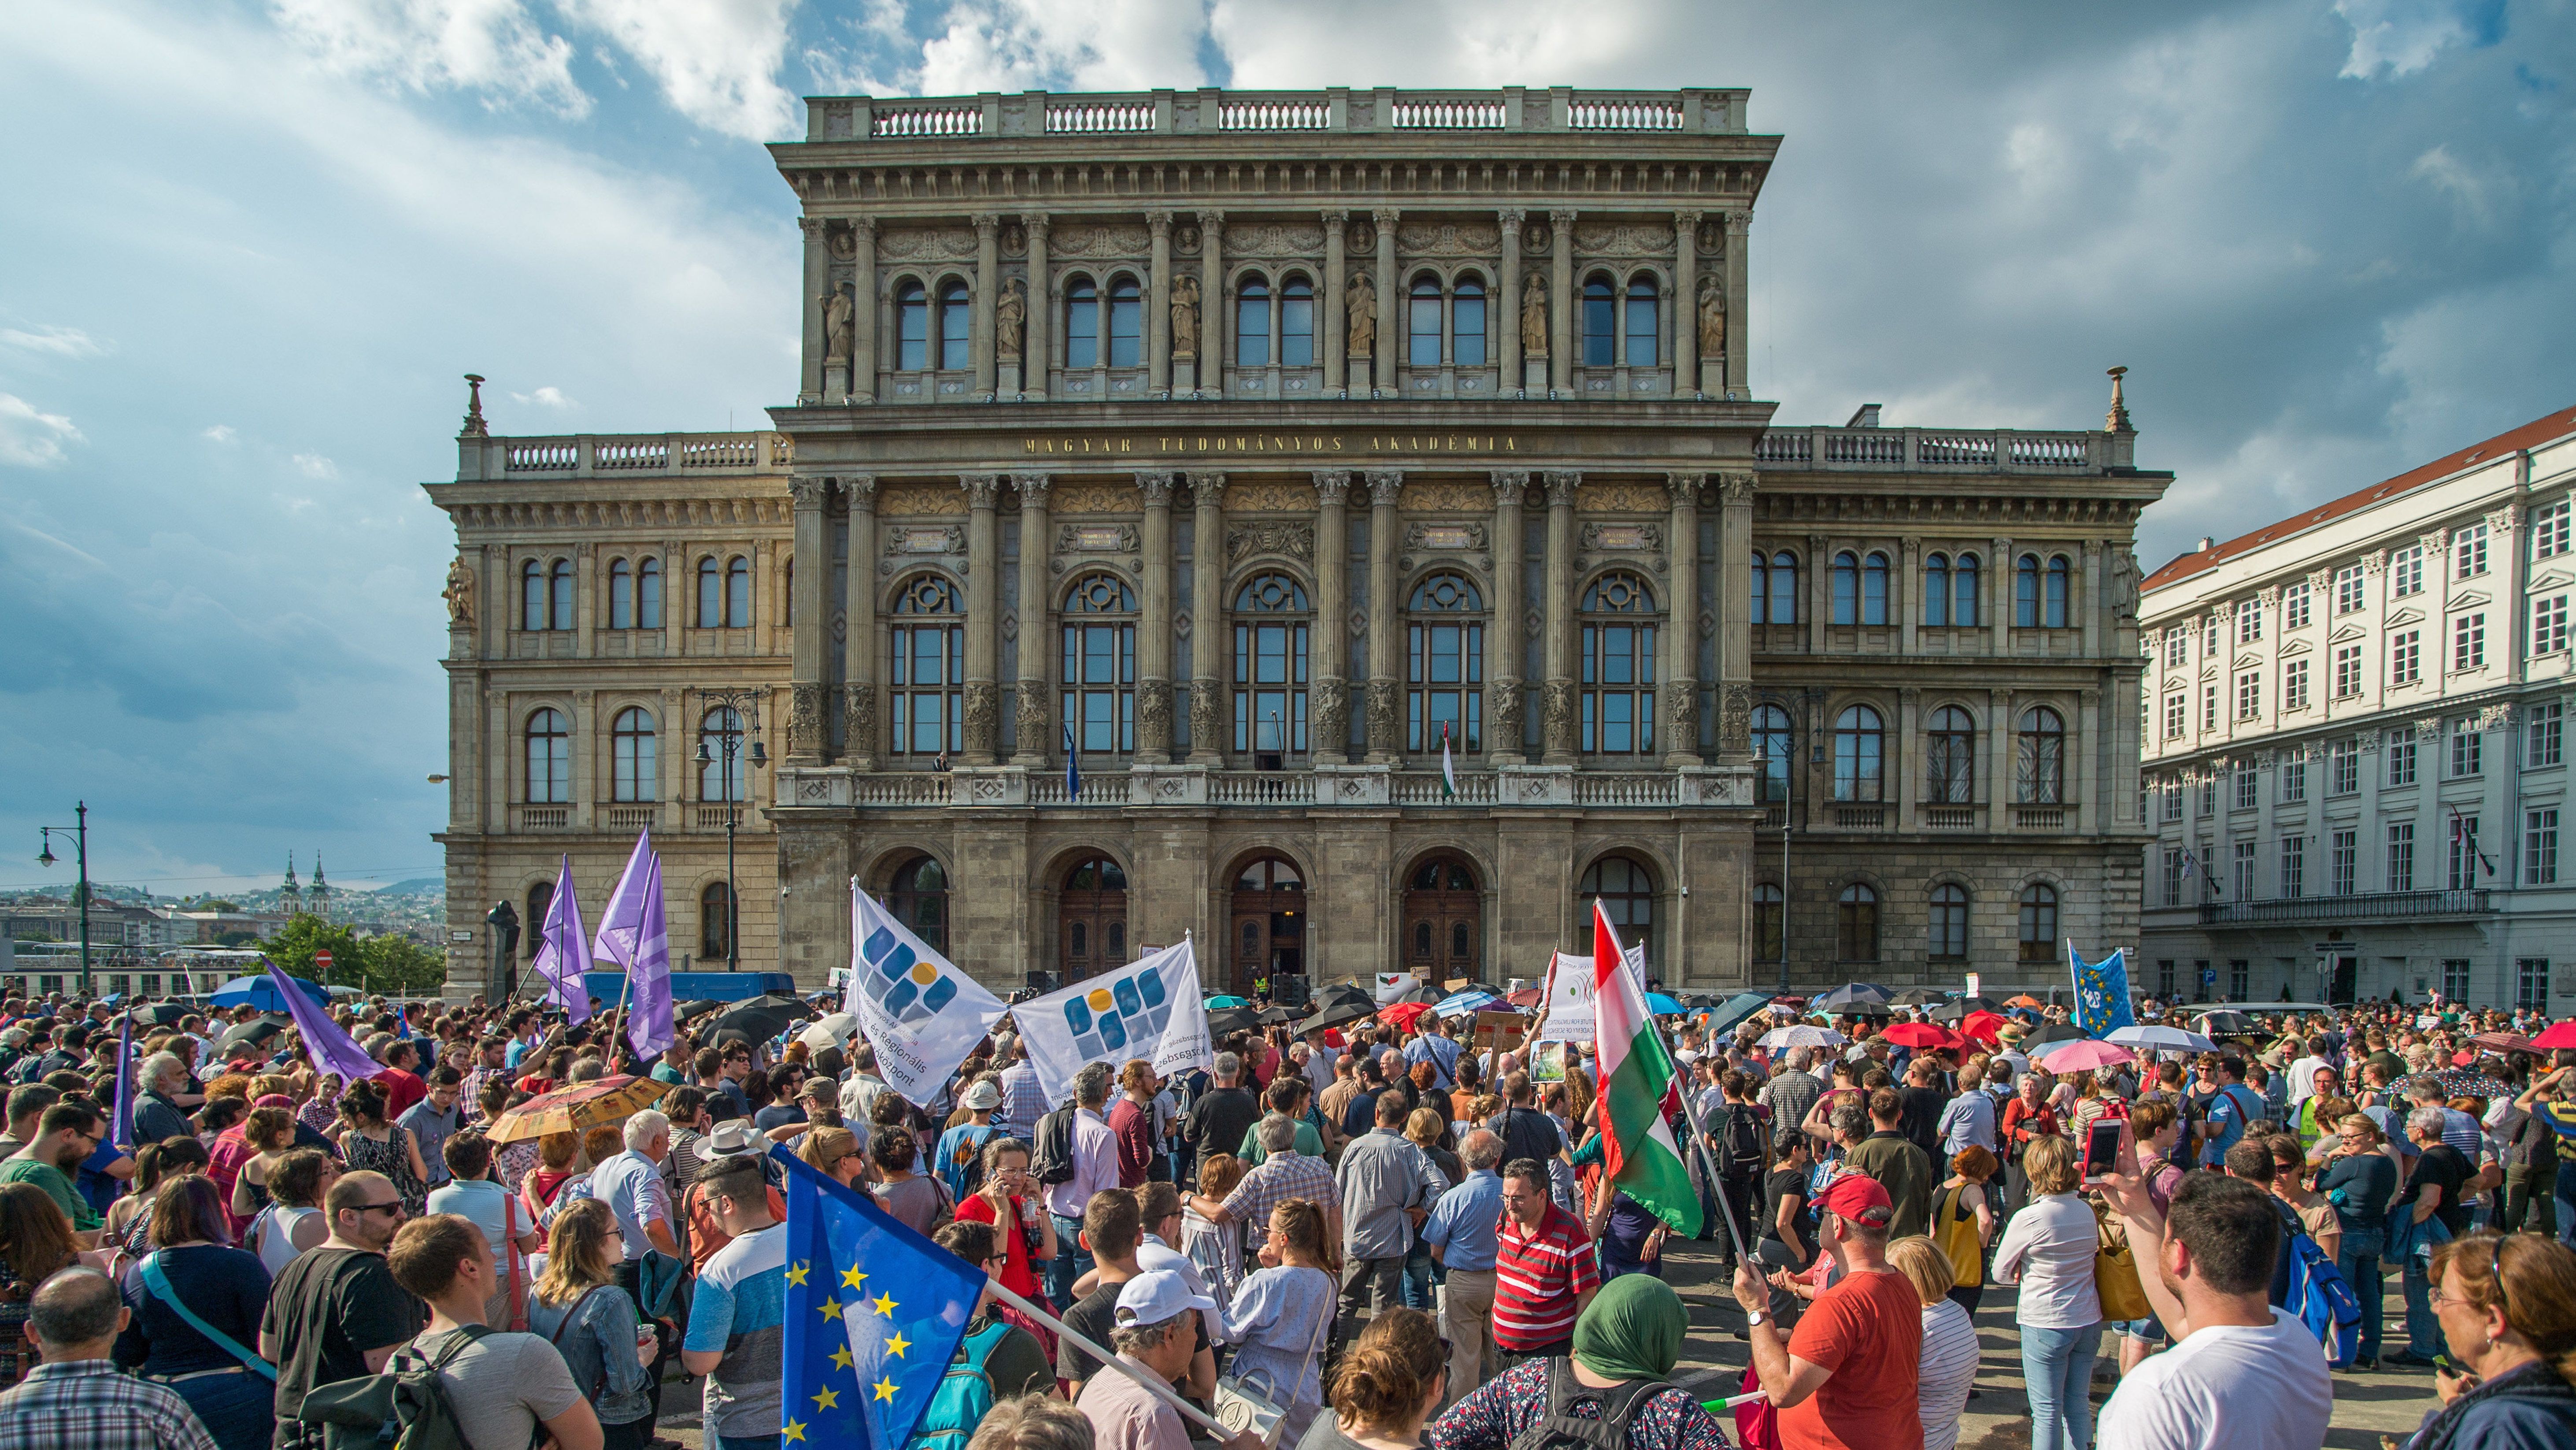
[{"left": 1592, "top": 901, "right": 1700, "bottom": 1239}]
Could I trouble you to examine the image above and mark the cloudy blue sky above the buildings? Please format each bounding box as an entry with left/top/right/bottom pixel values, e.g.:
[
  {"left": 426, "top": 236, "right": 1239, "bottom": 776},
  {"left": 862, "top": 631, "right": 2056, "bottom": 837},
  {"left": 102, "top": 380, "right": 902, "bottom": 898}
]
[{"left": 0, "top": 0, "right": 2576, "bottom": 891}]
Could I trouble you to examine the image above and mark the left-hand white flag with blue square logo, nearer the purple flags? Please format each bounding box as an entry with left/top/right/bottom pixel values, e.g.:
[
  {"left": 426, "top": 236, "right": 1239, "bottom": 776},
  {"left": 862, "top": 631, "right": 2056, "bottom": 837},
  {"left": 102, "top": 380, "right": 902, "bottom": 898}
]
[{"left": 842, "top": 881, "right": 1007, "bottom": 1102}]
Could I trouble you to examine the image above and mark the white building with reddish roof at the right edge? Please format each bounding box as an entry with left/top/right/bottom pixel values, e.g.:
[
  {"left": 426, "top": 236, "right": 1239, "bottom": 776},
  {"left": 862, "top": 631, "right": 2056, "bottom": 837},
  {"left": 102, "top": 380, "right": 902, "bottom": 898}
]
[{"left": 2138, "top": 399, "right": 2576, "bottom": 1007}]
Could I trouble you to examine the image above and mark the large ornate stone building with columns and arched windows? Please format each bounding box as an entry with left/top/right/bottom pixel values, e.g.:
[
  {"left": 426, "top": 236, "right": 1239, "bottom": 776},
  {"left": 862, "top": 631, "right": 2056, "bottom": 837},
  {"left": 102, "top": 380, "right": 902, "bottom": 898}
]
[{"left": 428, "top": 88, "right": 2169, "bottom": 992}]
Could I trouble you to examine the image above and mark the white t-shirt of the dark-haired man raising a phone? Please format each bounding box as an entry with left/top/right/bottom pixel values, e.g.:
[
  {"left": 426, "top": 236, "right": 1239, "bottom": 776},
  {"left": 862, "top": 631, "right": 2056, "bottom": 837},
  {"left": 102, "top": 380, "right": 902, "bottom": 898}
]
[{"left": 2094, "top": 1308, "right": 2334, "bottom": 1450}]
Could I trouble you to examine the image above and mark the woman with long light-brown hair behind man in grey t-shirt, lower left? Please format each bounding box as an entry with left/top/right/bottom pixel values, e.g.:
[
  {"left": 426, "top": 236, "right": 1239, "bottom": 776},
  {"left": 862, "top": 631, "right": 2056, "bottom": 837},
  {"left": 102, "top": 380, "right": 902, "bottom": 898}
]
[{"left": 528, "top": 1198, "right": 657, "bottom": 1450}]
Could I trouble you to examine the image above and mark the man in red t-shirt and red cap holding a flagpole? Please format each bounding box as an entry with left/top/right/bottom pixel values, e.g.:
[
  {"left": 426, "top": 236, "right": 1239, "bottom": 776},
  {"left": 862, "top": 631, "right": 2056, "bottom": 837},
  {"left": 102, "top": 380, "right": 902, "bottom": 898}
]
[{"left": 1734, "top": 1172, "right": 1924, "bottom": 1450}]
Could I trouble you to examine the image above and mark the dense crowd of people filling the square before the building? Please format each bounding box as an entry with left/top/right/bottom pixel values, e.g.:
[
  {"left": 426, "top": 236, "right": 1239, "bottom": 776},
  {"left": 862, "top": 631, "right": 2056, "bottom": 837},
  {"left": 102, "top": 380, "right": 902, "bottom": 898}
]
[{"left": 0, "top": 999, "right": 2576, "bottom": 1450}]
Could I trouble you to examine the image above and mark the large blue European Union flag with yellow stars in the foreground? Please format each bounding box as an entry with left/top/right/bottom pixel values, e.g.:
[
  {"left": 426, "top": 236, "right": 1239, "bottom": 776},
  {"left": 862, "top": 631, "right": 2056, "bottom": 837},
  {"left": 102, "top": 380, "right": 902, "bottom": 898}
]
[{"left": 770, "top": 1146, "right": 984, "bottom": 1450}]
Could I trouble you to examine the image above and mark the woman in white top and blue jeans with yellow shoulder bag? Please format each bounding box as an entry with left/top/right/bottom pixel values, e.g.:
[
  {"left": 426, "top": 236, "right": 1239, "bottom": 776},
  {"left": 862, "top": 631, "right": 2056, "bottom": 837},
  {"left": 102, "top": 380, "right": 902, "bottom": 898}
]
[{"left": 1994, "top": 1133, "right": 2102, "bottom": 1450}]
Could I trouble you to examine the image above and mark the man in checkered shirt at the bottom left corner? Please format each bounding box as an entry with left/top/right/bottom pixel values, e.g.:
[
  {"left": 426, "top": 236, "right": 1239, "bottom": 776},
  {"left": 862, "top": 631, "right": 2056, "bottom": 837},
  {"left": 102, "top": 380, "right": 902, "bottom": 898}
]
[{"left": 0, "top": 1267, "right": 216, "bottom": 1450}]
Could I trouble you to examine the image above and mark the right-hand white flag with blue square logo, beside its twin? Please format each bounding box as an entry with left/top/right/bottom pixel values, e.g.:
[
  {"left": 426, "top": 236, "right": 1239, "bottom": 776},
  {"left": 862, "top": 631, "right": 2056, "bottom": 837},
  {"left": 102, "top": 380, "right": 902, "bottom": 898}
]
[{"left": 1010, "top": 940, "right": 1216, "bottom": 1102}]
